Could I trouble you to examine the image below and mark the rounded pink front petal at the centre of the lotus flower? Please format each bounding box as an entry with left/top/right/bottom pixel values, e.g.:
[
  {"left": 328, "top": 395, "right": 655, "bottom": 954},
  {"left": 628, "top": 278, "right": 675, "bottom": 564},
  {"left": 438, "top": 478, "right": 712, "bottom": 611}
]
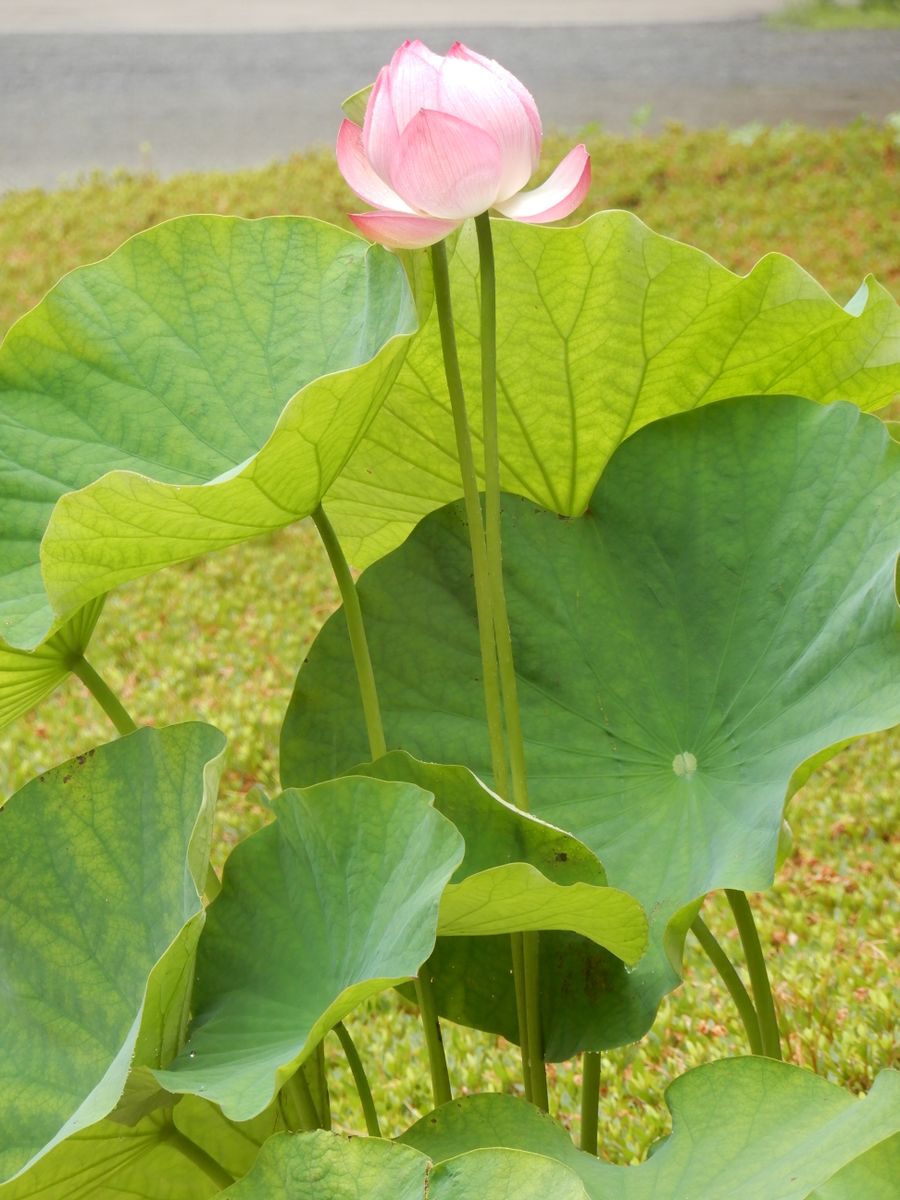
[{"left": 390, "top": 109, "right": 503, "bottom": 221}]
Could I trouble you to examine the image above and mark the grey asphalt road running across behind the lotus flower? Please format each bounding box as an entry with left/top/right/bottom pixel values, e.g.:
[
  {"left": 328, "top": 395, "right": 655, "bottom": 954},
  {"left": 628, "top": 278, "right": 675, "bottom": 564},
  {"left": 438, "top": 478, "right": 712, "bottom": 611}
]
[{"left": 0, "top": 16, "right": 900, "bottom": 192}]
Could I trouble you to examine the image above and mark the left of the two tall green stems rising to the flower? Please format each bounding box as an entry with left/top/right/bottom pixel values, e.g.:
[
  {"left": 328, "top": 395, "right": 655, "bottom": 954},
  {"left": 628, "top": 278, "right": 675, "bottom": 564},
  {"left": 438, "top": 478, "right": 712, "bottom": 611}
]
[{"left": 431, "top": 241, "right": 508, "bottom": 797}]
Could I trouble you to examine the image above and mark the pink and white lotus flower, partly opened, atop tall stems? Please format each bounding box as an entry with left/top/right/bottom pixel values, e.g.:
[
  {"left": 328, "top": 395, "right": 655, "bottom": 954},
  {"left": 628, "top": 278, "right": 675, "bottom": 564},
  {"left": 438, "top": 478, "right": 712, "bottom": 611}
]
[{"left": 337, "top": 41, "right": 590, "bottom": 250}]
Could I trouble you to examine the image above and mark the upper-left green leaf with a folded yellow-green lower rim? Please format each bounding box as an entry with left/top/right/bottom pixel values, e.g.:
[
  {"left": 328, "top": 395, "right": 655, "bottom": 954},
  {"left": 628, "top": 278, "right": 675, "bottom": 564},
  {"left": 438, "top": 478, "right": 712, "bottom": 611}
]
[{"left": 0, "top": 216, "right": 415, "bottom": 667}]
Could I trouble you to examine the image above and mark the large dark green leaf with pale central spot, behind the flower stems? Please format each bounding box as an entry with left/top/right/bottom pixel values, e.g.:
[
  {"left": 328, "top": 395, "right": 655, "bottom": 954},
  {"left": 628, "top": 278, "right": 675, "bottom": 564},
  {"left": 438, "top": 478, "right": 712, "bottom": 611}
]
[{"left": 282, "top": 397, "right": 900, "bottom": 1056}]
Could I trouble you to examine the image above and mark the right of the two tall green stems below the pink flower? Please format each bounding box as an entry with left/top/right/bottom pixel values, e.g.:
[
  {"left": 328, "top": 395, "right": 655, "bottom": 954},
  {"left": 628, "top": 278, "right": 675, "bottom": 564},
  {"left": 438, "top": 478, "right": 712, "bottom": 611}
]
[{"left": 475, "top": 212, "right": 547, "bottom": 1108}]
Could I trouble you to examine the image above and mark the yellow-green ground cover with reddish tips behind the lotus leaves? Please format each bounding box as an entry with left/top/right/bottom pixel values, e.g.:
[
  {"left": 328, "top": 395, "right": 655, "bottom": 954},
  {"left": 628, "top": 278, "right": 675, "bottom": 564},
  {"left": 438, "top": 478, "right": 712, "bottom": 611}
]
[{"left": 0, "top": 124, "right": 900, "bottom": 1163}]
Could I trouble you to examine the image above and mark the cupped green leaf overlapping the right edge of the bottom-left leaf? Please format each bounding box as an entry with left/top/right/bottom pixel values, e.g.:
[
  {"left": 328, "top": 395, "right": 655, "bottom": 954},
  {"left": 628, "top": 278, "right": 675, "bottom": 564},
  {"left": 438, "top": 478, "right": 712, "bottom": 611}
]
[{"left": 156, "top": 778, "right": 463, "bottom": 1121}]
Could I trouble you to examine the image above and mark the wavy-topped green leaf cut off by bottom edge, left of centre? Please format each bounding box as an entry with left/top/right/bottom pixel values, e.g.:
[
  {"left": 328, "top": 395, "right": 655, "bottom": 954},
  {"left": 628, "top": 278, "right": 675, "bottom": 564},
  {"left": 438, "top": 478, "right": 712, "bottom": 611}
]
[{"left": 222, "top": 1132, "right": 588, "bottom": 1200}]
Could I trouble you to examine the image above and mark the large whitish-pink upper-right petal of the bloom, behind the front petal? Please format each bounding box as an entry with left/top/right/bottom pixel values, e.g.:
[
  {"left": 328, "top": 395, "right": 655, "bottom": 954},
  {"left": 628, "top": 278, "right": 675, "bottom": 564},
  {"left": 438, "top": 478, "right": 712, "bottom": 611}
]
[{"left": 438, "top": 58, "right": 534, "bottom": 200}]
